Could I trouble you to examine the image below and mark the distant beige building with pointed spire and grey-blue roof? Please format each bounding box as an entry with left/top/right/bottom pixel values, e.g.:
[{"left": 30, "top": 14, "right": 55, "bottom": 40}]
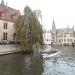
[{"left": 52, "top": 20, "right": 75, "bottom": 45}]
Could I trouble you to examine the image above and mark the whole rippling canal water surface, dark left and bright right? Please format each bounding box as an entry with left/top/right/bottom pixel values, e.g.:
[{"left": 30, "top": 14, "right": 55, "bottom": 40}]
[{"left": 0, "top": 46, "right": 75, "bottom": 75}]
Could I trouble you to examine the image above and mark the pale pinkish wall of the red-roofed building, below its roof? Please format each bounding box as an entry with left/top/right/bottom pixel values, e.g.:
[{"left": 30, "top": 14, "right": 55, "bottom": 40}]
[{"left": 0, "top": 20, "right": 15, "bottom": 41}]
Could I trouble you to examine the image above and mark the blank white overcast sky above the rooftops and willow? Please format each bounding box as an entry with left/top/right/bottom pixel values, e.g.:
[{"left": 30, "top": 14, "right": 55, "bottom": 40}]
[{"left": 0, "top": 0, "right": 75, "bottom": 30}]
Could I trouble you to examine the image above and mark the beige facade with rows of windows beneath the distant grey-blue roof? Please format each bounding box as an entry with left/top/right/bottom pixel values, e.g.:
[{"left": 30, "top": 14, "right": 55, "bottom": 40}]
[{"left": 55, "top": 33, "right": 75, "bottom": 45}]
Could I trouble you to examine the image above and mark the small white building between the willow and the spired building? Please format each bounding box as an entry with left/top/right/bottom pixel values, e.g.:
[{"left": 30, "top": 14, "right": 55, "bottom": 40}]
[{"left": 43, "top": 30, "right": 51, "bottom": 44}]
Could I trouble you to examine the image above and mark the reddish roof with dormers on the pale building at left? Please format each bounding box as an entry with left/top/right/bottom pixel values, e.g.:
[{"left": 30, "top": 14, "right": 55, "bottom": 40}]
[{"left": 0, "top": 1, "right": 20, "bottom": 22}]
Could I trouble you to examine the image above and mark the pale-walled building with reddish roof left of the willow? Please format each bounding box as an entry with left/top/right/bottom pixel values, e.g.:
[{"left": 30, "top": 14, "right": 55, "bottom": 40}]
[{"left": 0, "top": 0, "right": 20, "bottom": 42}]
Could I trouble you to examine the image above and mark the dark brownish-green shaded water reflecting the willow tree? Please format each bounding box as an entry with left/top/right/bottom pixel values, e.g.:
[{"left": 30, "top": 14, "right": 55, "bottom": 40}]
[{"left": 0, "top": 54, "right": 43, "bottom": 75}]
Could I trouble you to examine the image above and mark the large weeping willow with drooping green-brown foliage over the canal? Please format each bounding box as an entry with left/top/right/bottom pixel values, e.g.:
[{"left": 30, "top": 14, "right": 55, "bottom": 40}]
[{"left": 15, "top": 6, "right": 43, "bottom": 52}]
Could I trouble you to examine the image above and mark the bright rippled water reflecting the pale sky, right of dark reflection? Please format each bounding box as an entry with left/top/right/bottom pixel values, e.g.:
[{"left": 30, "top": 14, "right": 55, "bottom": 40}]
[{"left": 43, "top": 46, "right": 75, "bottom": 75}]
